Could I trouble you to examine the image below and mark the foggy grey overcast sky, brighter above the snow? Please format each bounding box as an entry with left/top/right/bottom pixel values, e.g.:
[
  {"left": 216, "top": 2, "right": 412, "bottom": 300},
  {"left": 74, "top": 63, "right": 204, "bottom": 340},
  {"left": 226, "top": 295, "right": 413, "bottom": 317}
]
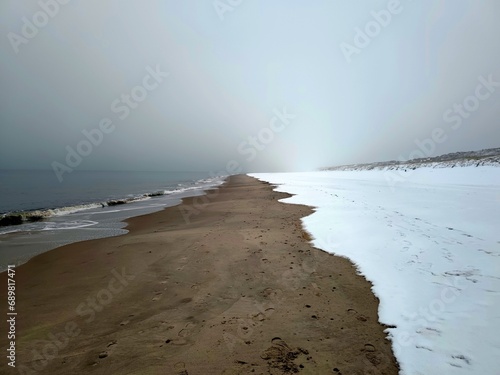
[{"left": 0, "top": 0, "right": 500, "bottom": 171}]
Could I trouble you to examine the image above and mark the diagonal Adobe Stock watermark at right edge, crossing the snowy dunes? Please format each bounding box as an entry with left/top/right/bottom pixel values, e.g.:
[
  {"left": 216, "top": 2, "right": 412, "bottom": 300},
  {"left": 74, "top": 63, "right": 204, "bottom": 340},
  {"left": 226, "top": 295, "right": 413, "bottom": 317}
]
[{"left": 384, "top": 74, "right": 500, "bottom": 191}]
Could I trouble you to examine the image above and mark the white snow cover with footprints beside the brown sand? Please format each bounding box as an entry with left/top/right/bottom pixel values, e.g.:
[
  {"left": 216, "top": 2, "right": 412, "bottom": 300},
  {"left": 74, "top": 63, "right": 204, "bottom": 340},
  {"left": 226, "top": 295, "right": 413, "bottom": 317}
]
[{"left": 250, "top": 166, "right": 500, "bottom": 375}]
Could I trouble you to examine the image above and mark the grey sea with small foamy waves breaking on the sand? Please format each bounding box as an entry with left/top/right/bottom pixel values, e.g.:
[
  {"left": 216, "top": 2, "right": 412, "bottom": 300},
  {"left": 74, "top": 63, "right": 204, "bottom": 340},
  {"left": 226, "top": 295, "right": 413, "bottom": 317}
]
[{"left": 0, "top": 171, "right": 223, "bottom": 272}]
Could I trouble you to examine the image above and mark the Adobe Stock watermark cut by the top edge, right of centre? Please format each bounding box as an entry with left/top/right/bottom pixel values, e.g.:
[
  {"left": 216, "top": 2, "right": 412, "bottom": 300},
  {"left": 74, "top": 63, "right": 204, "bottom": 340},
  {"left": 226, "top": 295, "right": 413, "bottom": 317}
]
[{"left": 340, "top": 0, "right": 411, "bottom": 63}]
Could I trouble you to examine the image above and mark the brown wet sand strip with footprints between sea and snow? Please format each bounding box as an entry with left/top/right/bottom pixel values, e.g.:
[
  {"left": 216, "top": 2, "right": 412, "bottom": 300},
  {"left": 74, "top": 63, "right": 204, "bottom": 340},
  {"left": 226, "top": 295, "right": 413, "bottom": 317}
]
[{"left": 0, "top": 176, "right": 398, "bottom": 375}]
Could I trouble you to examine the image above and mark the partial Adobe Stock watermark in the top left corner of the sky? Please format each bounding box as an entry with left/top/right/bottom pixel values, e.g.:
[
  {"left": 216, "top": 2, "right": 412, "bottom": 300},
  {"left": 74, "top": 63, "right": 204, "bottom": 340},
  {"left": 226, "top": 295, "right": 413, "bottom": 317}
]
[{"left": 7, "top": 0, "right": 71, "bottom": 55}]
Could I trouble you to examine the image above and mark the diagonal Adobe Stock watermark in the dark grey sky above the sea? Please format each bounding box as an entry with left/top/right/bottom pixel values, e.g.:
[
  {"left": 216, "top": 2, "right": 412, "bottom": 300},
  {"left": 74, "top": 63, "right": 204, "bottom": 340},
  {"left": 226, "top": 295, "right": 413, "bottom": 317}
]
[{"left": 51, "top": 65, "right": 170, "bottom": 182}]
